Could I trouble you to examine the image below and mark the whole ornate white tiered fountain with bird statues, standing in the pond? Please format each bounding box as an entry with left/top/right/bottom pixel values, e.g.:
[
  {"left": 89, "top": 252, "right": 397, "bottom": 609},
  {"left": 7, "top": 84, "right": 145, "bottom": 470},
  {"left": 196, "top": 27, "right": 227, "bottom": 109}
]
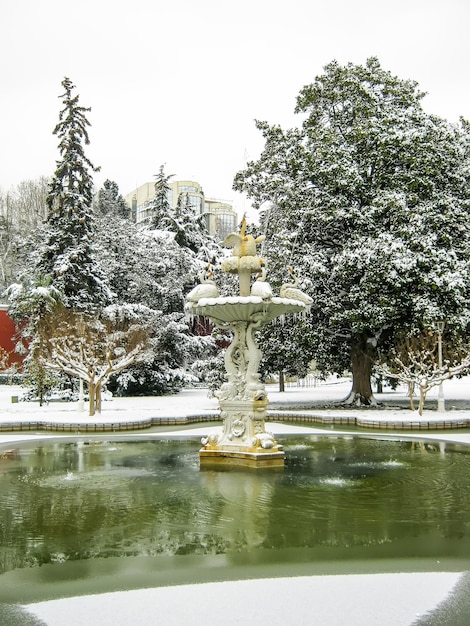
[{"left": 185, "top": 218, "right": 312, "bottom": 467}]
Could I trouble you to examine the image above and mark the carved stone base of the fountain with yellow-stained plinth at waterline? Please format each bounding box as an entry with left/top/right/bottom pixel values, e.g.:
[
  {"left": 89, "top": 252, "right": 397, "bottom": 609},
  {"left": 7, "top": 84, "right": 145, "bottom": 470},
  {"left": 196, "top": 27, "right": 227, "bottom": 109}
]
[{"left": 199, "top": 395, "right": 284, "bottom": 467}]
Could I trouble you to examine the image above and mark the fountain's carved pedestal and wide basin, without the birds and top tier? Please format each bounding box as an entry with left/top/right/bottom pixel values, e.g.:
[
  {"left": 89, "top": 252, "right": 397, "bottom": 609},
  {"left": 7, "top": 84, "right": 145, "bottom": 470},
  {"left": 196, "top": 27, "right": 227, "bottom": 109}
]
[{"left": 186, "top": 296, "right": 305, "bottom": 467}]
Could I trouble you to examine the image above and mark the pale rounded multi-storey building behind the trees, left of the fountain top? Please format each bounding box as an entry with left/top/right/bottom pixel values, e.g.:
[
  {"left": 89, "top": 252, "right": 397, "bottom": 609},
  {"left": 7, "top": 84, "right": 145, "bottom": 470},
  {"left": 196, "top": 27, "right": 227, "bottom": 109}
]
[{"left": 125, "top": 180, "right": 238, "bottom": 239}]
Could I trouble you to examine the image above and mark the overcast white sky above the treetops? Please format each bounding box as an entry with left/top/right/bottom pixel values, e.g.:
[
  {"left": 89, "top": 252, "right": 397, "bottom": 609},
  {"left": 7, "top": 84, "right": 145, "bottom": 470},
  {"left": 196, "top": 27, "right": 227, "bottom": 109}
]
[{"left": 0, "top": 0, "right": 470, "bottom": 213}]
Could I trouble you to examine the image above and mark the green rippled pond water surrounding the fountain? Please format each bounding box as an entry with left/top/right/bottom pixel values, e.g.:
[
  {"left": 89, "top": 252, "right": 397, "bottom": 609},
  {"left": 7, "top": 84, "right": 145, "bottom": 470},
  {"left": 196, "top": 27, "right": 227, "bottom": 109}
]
[{"left": 0, "top": 437, "right": 470, "bottom": 602}]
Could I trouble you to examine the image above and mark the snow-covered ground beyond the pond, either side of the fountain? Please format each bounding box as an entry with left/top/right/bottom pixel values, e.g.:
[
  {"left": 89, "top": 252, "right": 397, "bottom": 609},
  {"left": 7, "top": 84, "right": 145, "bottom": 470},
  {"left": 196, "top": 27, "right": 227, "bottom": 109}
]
[{"left": 0, "top": 377, "right": 470, "bottom": 444}]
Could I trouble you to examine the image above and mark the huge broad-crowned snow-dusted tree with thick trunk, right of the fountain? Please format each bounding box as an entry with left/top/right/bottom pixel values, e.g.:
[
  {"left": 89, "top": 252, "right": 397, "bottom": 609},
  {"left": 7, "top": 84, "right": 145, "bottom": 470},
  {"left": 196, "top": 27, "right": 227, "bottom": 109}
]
[{"left": 234, "top": 58, "right": 470, "bottom": 404}]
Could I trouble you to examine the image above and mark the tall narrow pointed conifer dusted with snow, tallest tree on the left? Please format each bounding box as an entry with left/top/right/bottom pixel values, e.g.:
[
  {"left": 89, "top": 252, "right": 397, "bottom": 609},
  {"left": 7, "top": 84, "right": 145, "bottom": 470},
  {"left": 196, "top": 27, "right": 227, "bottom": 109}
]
[{"left": 37, "top": 78, "right": 111, "bottom": 311}]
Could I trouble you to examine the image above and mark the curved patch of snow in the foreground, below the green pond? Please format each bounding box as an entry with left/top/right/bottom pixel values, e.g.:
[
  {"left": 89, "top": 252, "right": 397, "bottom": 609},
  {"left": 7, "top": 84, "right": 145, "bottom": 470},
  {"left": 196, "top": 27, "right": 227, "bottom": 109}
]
[{"left": 21, "top": 572, "right": 461, "bottom": 626}]
